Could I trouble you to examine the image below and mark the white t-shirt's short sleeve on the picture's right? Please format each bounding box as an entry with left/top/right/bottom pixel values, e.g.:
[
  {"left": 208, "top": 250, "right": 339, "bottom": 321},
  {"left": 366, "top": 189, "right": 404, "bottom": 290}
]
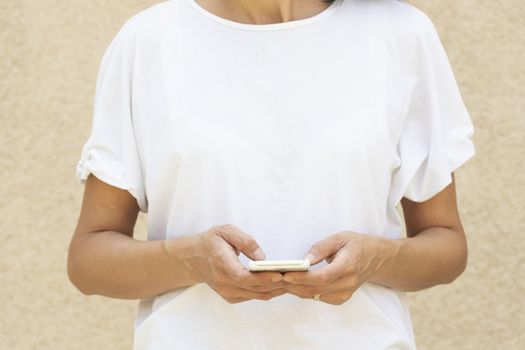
[{"left": 391, "top": 10, "right": 475, "bottom": 205}]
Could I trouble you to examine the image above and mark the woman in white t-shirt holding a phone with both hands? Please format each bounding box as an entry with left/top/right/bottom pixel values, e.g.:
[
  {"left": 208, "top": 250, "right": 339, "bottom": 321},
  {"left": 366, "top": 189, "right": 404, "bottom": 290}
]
[{"left": 68, "top": 0, "right": 475, "bottom": 350}]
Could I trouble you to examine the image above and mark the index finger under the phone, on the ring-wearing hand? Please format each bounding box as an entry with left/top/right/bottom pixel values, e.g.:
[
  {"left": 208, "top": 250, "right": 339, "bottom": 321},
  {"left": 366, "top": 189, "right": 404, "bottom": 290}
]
[{"left": 283, "top": 250, "right": 353, "bottom": 285}]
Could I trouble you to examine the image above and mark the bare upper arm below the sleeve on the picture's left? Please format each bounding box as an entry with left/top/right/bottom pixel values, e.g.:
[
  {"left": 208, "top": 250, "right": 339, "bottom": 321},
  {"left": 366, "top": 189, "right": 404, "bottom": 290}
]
[{"left": 75, "top": 174, "right": 139, "bottom": 237}]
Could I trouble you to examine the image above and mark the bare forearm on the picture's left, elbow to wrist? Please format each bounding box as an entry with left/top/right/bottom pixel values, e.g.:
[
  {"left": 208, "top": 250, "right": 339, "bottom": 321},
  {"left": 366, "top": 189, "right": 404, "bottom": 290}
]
[{"left": 68, "top": 231, "right": 203, "bottom": 299}]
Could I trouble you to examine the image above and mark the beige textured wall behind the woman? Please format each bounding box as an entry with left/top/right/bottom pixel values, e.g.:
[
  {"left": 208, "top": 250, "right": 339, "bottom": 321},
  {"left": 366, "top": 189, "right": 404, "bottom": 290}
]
[{"left": 0, "top": 0, "right": 525, "bottom": 350}]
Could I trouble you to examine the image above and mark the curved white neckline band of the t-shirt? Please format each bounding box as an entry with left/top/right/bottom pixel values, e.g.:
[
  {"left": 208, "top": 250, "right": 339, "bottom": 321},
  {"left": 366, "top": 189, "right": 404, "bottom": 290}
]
[{"left": 186, "top": 0, "right": 344, "bottom": 31}]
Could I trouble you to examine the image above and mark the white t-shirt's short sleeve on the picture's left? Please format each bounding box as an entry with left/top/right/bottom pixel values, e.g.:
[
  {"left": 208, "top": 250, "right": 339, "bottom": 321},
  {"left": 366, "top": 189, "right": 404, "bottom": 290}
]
[{"left": 76, "top": 20, "right": 147, "bottom": 212}]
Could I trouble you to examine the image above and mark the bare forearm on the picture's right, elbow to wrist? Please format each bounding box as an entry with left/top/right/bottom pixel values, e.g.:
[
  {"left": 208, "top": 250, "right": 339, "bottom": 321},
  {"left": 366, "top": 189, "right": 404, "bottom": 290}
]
[{"left": 369, "top": 227, "right": 467, "bottom": 291}]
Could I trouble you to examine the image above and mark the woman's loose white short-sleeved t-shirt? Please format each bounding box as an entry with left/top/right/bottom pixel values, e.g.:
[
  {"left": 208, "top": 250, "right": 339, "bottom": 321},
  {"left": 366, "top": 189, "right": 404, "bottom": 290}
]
[{"left": 76, "top": 0, "right": 475, "bottom": 350}]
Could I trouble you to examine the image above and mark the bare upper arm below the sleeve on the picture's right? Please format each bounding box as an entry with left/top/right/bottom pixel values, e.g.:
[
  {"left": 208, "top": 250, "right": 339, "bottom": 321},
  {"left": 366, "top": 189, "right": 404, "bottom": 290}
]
[{"left": 401, "top": 173, "right": 464, "bottom": 237}]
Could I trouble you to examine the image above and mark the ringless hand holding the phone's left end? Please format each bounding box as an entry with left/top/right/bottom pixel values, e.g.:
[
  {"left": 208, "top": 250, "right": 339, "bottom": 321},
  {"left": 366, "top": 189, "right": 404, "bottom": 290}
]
[{"left": 189, "top": 224, "right": 287, "bottom": 304}]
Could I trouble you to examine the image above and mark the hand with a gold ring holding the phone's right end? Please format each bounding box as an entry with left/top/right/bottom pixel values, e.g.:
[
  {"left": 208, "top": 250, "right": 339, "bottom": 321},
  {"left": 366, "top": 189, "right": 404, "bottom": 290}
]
[{"left": 283, "top": 231, "right": 394, "bottom": 305}]
